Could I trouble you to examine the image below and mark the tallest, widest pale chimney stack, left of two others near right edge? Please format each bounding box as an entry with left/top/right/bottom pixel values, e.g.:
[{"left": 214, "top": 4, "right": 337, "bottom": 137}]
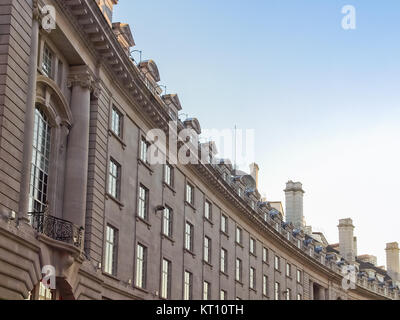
[{"left": 284, "top": 181, "right": 305, "bottom": 229}]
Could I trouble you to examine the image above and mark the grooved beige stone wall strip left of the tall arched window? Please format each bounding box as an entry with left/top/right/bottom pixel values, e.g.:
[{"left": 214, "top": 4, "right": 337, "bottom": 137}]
[{"left": 0, "top": 0, "right": 32, "bottom": 212}]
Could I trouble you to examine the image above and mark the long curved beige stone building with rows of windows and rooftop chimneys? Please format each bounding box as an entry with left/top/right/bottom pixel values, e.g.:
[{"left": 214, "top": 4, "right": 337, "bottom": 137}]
[{"left": 0, "top": 0, "right": 399, "bottom": 300}]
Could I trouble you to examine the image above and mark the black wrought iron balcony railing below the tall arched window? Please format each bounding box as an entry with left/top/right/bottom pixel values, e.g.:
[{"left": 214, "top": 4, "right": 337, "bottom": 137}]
[{"left": 30, "top": 213, "right": 84, "bottom": 249}]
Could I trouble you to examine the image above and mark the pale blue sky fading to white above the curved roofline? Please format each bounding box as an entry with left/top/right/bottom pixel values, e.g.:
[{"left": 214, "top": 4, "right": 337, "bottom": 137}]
[{"left": 114, "top": 0, "right": 400, "bottom": 265}]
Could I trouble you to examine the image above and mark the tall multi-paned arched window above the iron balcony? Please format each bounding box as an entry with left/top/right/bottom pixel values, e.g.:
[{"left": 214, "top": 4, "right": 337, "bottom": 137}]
[{"left": 29, "top": 108, "right": 51, "bottom": 213}]
